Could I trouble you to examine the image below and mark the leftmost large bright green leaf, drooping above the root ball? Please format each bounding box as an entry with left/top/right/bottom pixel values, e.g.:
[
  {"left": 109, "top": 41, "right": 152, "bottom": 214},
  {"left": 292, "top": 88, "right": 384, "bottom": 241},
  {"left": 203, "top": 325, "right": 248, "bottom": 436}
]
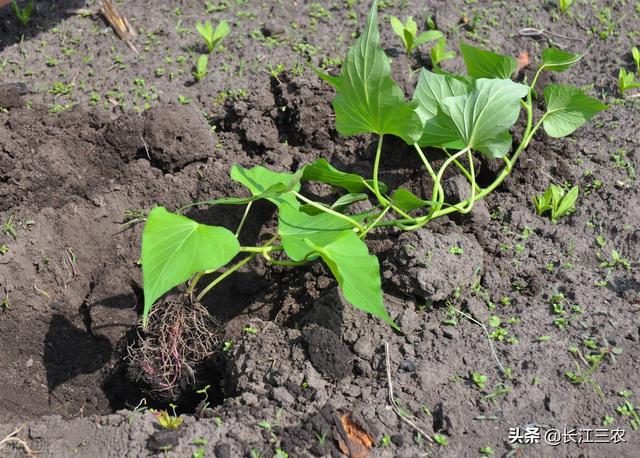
[{"left": 142, "top": 207, "right": 240, "bottom": 326}]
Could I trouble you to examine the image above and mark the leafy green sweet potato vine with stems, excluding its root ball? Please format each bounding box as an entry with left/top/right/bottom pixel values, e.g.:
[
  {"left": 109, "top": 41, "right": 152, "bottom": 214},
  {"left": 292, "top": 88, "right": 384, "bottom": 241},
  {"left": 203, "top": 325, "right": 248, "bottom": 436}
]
[{"left": 142, "top": 0, "right": 606, "bottom": 328}]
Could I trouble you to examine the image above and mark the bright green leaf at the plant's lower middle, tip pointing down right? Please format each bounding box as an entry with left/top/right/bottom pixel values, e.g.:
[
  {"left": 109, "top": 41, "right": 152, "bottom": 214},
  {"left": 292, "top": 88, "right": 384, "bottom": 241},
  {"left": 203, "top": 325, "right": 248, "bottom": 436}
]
[{"left": 306, "top": 232, "right": 400, "bottom": 330}]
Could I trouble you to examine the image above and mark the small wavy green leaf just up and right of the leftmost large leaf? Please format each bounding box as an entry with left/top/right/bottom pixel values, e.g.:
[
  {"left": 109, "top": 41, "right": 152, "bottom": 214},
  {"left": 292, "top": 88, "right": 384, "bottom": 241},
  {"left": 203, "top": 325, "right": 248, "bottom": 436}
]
[{"left": 231, "top": 165, "right": 304, "bottom": 207}]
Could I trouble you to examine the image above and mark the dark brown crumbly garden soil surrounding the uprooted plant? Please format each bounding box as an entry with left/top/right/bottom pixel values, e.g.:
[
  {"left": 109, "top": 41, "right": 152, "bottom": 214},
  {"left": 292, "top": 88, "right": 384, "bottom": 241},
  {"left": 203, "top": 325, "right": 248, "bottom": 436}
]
[{"left": 0, "top": 0, "right": 640, "bottom": 457}]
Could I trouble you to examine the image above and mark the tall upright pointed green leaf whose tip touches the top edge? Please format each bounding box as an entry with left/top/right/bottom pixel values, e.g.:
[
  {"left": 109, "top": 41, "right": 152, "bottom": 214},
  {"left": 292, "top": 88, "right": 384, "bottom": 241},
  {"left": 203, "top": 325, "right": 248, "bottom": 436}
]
[{"left": 333, "top": 0, "right": 422, "bottom": 145}]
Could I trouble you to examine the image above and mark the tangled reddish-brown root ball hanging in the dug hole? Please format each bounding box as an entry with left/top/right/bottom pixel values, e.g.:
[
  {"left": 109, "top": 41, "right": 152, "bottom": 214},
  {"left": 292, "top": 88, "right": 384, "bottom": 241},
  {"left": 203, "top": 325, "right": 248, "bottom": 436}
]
[{"left": 127, "top": 296, "right": 220, "bottom": 400}]
